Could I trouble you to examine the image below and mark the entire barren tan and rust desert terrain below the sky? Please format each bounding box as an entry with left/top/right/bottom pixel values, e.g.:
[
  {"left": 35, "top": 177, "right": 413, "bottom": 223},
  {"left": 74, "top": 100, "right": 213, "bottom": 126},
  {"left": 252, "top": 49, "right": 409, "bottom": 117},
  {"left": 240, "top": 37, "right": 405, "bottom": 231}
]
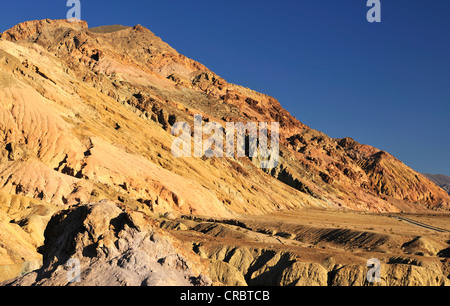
[{"left": 0, "top": 20, "right": 450, "bottom": 286}]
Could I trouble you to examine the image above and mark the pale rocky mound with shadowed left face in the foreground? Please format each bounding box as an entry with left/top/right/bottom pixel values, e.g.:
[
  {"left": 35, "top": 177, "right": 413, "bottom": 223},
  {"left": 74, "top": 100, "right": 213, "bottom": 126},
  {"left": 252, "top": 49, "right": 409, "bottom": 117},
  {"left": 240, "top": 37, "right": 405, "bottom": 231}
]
[{"left": 0, "top": 201, "right": 211, "bottom": 286}]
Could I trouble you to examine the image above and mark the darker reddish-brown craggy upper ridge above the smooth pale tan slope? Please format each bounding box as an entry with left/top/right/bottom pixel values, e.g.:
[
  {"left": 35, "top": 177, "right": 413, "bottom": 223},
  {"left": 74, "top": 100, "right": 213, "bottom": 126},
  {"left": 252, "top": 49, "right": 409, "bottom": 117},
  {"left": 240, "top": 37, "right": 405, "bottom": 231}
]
[{"left": 1, "top": 20, "right": 450, "bottom": 215}]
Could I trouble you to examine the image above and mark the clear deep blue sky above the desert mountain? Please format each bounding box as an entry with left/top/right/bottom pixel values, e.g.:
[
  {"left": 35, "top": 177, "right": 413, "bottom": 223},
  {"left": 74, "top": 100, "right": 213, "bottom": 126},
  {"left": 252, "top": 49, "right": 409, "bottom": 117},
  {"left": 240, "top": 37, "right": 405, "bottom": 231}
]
[{"left": 0, "top": 0, "right": 450, "bottom": 175}]
